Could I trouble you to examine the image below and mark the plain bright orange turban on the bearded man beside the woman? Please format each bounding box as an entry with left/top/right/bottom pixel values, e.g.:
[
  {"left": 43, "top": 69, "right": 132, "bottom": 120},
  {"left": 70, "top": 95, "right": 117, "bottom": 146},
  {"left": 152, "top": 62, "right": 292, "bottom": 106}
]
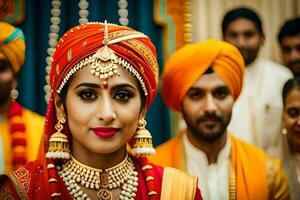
[{"left": 162, "top": 39, "right": 244, "bottom": 111}]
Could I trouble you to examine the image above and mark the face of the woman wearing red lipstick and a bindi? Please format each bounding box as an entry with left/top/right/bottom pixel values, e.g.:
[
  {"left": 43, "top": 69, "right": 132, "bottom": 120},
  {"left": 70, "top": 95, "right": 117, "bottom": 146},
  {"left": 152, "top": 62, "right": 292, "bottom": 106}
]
[{"left": 60, "top": 66, "right": 145, "bottom": 154}]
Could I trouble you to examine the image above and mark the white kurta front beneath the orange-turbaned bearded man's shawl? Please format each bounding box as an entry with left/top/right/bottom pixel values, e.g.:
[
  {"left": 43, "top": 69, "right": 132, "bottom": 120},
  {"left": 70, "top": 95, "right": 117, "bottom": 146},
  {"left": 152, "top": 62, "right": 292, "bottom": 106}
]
[{"left": 183, "top": 134, "right": 231, "bottom": 200}]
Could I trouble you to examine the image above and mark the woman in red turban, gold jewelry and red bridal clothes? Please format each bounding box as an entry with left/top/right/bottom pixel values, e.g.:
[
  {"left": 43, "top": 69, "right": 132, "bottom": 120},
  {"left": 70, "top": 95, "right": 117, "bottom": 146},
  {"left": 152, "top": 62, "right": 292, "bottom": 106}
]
[{"left": 0, "top": 23, "right": 201, "bottom": 200}]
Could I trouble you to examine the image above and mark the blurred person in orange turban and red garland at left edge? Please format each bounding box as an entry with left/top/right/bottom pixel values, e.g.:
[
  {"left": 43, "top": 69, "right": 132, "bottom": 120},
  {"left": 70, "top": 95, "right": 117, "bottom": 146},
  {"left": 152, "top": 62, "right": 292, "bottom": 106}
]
[{"left": 0, "top": 22, "right": 44, "bottom": 174}]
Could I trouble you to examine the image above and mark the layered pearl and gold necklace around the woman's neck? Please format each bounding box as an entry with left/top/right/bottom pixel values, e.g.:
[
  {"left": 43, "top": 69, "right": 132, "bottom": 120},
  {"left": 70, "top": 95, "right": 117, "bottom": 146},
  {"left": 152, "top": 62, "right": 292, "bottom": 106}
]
[{"left": 58, "top": 155, "right": 138, "bottom": 200}]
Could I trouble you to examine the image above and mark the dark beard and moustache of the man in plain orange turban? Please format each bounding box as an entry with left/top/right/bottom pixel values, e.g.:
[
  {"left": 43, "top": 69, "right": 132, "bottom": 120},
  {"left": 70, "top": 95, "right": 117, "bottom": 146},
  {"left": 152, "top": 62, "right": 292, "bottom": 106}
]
[{"left": 183, "top": 112, "right": 231, "bottom": 143}]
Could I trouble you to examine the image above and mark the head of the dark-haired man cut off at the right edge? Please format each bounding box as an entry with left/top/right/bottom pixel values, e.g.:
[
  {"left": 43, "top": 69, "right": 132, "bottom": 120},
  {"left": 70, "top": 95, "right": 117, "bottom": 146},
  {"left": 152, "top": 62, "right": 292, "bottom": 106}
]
[{"left": 278, "top": 17, "right": 300, "bottom": 77}]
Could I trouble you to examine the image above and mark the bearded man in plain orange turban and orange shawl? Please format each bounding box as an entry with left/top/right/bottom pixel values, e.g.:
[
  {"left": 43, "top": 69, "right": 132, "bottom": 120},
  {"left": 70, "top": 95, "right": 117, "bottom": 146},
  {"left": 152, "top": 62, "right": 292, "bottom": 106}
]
[{"left": 150, "top": 39, "right": 289, "bottom": 200}]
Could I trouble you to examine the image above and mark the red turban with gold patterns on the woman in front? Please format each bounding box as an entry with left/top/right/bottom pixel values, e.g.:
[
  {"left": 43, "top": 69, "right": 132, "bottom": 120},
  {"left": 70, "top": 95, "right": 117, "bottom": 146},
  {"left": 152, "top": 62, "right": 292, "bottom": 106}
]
[{"left": 50, "top": 23, "right": 158, "bottom": 107}]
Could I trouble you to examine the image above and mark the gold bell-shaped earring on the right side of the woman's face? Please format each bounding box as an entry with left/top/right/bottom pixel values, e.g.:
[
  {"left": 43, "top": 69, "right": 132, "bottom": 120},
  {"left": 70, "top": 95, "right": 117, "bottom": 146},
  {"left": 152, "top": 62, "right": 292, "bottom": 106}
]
[{"left": 131, "top": 119, "right": 155, "bottom": 157}]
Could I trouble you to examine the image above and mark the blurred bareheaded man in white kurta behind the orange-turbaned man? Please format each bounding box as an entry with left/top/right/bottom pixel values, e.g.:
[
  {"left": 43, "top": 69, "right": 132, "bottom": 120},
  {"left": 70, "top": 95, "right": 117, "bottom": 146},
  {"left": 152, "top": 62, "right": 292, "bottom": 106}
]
[{"left": 222, "top": 8, "right": 292, "bottom": 155}]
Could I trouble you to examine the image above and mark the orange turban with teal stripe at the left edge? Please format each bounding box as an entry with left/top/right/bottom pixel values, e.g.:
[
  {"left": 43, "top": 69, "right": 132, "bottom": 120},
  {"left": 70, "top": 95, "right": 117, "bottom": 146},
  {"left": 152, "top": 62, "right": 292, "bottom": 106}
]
[{"left": 0, "top": 22, "right": 25, "bottom": 73}]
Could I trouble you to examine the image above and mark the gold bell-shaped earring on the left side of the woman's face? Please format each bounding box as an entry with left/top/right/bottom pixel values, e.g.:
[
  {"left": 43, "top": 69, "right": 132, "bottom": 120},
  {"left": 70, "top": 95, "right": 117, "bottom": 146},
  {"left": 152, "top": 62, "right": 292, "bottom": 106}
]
[{"left": 46, "top": 115, "right": 70, "bottom": 159}]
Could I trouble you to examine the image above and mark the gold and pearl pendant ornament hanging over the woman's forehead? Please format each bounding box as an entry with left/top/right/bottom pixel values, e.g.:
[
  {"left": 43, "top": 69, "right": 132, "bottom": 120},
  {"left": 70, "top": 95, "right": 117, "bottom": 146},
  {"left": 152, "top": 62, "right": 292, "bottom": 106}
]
[{"left": 91, "top": 20, "right": 119, "bottom": 89}]
